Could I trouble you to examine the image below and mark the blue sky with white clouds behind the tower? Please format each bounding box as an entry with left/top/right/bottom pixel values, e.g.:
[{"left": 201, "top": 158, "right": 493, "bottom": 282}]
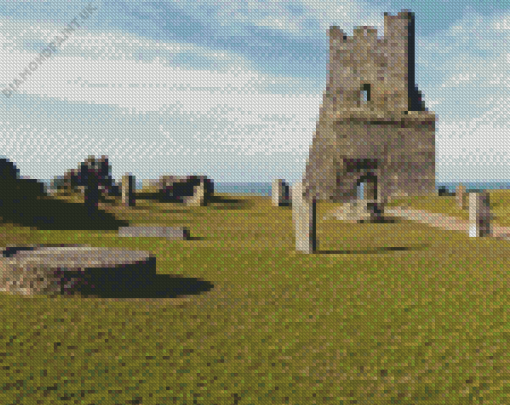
[{"left": 0, "top": 0, "right": 510, "bottom": 182}]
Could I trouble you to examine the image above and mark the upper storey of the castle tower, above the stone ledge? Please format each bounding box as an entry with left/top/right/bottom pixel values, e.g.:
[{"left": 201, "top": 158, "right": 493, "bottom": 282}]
[{"left": 324, "top": 12, "right": 424, "bottom": 112}]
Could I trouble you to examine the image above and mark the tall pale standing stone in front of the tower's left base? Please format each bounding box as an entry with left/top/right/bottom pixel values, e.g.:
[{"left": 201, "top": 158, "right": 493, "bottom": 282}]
[{"left": 292, "top": 181, "right": 317, "bottom": 254}]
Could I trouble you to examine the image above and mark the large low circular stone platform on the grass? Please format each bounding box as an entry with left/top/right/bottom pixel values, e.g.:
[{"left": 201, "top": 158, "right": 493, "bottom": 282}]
[{"left": 0, "top": 245, "right": 156, "bottom": 295}]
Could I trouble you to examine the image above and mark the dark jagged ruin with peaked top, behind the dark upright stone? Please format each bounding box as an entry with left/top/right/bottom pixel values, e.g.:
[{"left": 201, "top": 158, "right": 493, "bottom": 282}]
[{"left": 52, "top": 156, "right": 121, "bottom": 197}]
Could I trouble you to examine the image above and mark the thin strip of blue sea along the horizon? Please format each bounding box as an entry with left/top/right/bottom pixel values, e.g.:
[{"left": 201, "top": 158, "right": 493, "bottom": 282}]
[{"left": 36, "top": 180, "right": 510, "bottom": 196}]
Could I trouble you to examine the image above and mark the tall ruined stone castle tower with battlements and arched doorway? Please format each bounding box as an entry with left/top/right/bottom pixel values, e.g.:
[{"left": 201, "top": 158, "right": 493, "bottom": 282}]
[{"left": 303, "top": 11, "right": 436, "bottom": 203}]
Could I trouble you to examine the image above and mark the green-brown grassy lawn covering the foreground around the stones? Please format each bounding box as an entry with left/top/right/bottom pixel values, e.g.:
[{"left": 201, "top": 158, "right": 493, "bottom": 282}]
[{"left": 0, "top": 191, "right": 510, "bottom": 405}]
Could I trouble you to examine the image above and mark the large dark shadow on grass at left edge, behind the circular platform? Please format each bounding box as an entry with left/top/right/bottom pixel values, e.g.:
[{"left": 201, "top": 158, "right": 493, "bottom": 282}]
[{"left": 0, "top": 197, "right": 129, "bottom": 230}]
